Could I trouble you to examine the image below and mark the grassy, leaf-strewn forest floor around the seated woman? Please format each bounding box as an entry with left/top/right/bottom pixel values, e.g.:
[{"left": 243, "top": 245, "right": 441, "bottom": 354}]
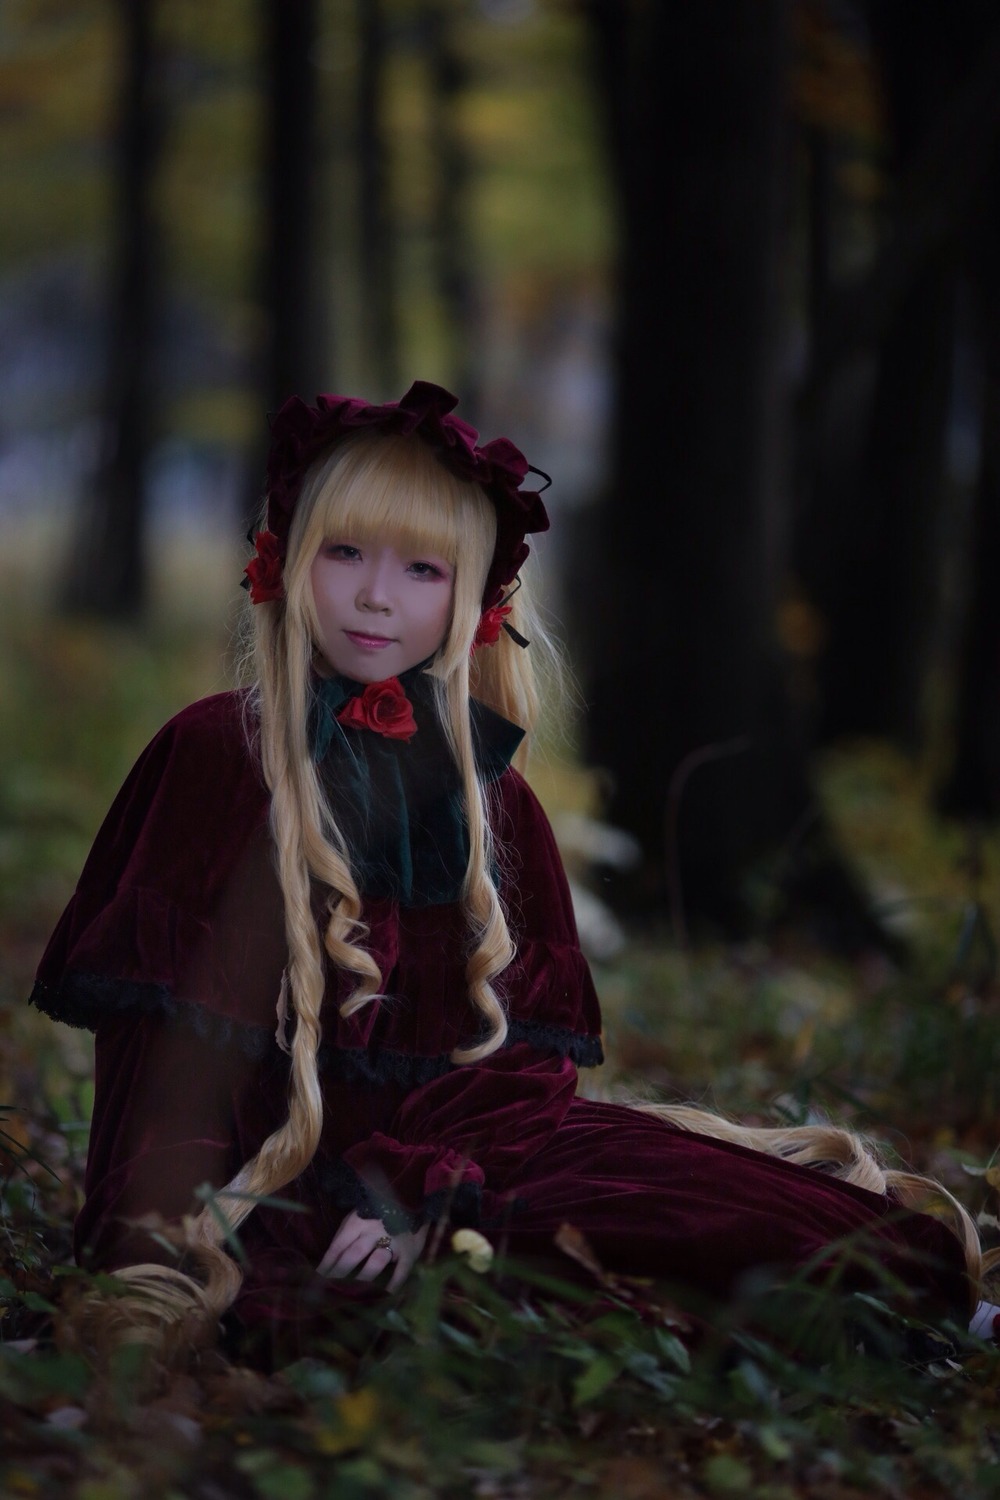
[{"left": 0, "top": 590, "right": 1000, "bottom": 1500}]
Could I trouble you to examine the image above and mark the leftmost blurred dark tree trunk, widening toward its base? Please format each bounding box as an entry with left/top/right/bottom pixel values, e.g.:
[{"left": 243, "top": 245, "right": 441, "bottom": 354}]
[{"left": 63, "top": 0, "right": 163, "bottom": 620}]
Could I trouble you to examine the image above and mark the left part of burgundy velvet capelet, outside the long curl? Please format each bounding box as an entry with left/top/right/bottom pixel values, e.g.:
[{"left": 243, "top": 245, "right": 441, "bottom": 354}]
[{"left": 31, "top": 693, "right": 273, "bottom": 1034}]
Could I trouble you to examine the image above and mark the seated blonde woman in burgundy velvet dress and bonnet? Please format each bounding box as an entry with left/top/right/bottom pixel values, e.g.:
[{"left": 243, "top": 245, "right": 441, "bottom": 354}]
[{"left": 33, "top": 383, "right": 979, "bottom": 1344}]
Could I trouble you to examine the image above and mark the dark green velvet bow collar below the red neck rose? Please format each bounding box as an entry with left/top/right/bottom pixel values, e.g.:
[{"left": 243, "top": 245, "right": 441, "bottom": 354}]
[{"left": 310, "top": 663, "right": 523, "bottom": 906}]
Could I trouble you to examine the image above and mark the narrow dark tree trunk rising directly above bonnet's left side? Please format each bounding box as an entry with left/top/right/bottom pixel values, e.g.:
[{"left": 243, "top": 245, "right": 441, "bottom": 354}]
[{"left": 262, "top": 0, "right": 325, "bottom": 411}]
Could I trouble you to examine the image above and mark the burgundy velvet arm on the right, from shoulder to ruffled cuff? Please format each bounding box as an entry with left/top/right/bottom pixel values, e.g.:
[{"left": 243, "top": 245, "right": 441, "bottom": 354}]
[{"left": 338, "top": 771, "right": 601, "bottom": 1223}]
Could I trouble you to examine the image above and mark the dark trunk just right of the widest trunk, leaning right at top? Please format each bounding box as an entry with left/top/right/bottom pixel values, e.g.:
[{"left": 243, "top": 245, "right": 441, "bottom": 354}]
[{"left": 795, "top": 0, "right": 1000, "bottom": 749}]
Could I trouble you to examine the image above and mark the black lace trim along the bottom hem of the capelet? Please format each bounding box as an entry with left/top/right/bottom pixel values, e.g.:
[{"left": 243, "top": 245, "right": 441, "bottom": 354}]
[{"left": 28, "top": 974, "right": 604, "bottom": 1089}]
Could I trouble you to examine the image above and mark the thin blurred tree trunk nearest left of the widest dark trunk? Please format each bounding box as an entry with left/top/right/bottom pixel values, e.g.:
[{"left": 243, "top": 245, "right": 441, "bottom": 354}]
[{"left": 423, "top": 0, "right": 480, "bottom": 411}]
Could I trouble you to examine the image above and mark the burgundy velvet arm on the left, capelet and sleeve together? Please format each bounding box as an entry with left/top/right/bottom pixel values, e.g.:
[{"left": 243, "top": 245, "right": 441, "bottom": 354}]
[{"left": 31, "top": 695, "right": 286, "bottom": 1268}]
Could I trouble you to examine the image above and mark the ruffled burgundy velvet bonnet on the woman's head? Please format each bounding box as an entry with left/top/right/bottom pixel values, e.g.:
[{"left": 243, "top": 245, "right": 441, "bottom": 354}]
[{"left": 247, "top": 381, "right": 552, "bottom": 609}]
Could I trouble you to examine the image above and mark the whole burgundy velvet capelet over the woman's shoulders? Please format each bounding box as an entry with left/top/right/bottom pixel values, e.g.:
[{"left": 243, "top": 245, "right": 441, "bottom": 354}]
[{"left": 31, "top": 693, "right": 601, "bottom": 1085}]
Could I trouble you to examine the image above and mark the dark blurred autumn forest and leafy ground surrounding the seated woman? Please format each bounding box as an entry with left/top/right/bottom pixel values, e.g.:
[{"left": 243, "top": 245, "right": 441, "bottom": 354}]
[{"left": 0, "top": 0, "right": 1000, "bottom": 1500}]
